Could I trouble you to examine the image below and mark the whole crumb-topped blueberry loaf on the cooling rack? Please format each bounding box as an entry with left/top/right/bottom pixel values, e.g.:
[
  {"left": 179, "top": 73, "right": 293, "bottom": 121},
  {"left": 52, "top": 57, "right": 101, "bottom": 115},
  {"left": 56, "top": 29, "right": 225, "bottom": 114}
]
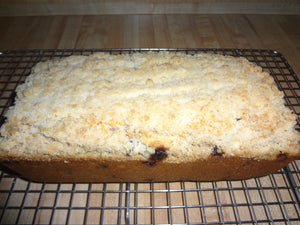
[{"left": 0, "top": 51, "right": 300, "bottom": 182}]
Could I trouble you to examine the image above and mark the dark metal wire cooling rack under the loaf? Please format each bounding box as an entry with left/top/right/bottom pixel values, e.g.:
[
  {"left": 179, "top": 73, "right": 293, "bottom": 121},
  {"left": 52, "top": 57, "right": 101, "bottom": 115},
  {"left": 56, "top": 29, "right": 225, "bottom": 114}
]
[{"left": 0, "top": 49, "right": 300, "bottom": 225}]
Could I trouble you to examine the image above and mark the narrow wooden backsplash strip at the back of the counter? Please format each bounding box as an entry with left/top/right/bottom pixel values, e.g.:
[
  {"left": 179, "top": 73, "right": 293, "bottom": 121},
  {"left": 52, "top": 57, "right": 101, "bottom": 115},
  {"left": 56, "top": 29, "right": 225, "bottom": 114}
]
[{"left": 0, "top": 0, "right": 300, "bottom": 16}]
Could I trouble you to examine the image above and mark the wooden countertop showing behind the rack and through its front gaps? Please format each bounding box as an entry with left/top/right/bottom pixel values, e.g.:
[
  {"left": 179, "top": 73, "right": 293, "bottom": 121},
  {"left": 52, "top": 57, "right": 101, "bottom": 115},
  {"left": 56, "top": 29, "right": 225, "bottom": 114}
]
[{"left": 0, "top": 14, "right": 300, "bottom": 224}]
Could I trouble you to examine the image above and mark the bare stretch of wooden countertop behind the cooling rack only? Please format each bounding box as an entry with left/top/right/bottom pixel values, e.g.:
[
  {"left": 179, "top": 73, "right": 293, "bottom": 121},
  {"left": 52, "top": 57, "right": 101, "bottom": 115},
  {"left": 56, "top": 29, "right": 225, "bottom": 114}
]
[{"left": 0, "top": 14, "right": 300, "bottom": 75}]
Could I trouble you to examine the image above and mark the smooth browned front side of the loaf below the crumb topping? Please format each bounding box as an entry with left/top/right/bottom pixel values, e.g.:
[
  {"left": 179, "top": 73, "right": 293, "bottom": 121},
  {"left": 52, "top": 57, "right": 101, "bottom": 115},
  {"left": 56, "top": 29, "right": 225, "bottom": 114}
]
[{"left": 0, "top": 156, "right": 298, "bottom": 182}]
